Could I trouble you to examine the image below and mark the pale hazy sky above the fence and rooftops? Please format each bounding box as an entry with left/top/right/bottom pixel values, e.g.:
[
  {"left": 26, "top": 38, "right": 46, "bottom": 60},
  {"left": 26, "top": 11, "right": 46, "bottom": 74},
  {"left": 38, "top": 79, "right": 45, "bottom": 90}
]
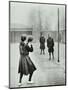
[{"left": 10, "top": 2, "right": 65, "bottom": 30}]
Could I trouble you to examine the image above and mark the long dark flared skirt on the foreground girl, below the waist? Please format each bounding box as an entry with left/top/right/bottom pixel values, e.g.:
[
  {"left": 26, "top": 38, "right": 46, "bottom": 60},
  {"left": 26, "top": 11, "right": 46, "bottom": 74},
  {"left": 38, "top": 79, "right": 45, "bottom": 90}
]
[{"left": 18, "top": 55, "right": 36, "bottom": 75}]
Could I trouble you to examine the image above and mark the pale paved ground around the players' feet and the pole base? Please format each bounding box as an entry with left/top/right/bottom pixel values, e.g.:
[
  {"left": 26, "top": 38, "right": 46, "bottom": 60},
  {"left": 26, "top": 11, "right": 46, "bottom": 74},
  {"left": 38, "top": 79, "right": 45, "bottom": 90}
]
[{"left": 10, "top": 43, "right": 65, "bottom": 87}]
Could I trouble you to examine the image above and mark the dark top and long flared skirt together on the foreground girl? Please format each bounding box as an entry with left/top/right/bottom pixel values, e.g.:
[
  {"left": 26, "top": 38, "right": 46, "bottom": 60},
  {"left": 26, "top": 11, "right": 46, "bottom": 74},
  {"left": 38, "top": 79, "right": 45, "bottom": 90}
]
[{"left": 18, "top": 41, "right": 36, "bottom": 75}]
